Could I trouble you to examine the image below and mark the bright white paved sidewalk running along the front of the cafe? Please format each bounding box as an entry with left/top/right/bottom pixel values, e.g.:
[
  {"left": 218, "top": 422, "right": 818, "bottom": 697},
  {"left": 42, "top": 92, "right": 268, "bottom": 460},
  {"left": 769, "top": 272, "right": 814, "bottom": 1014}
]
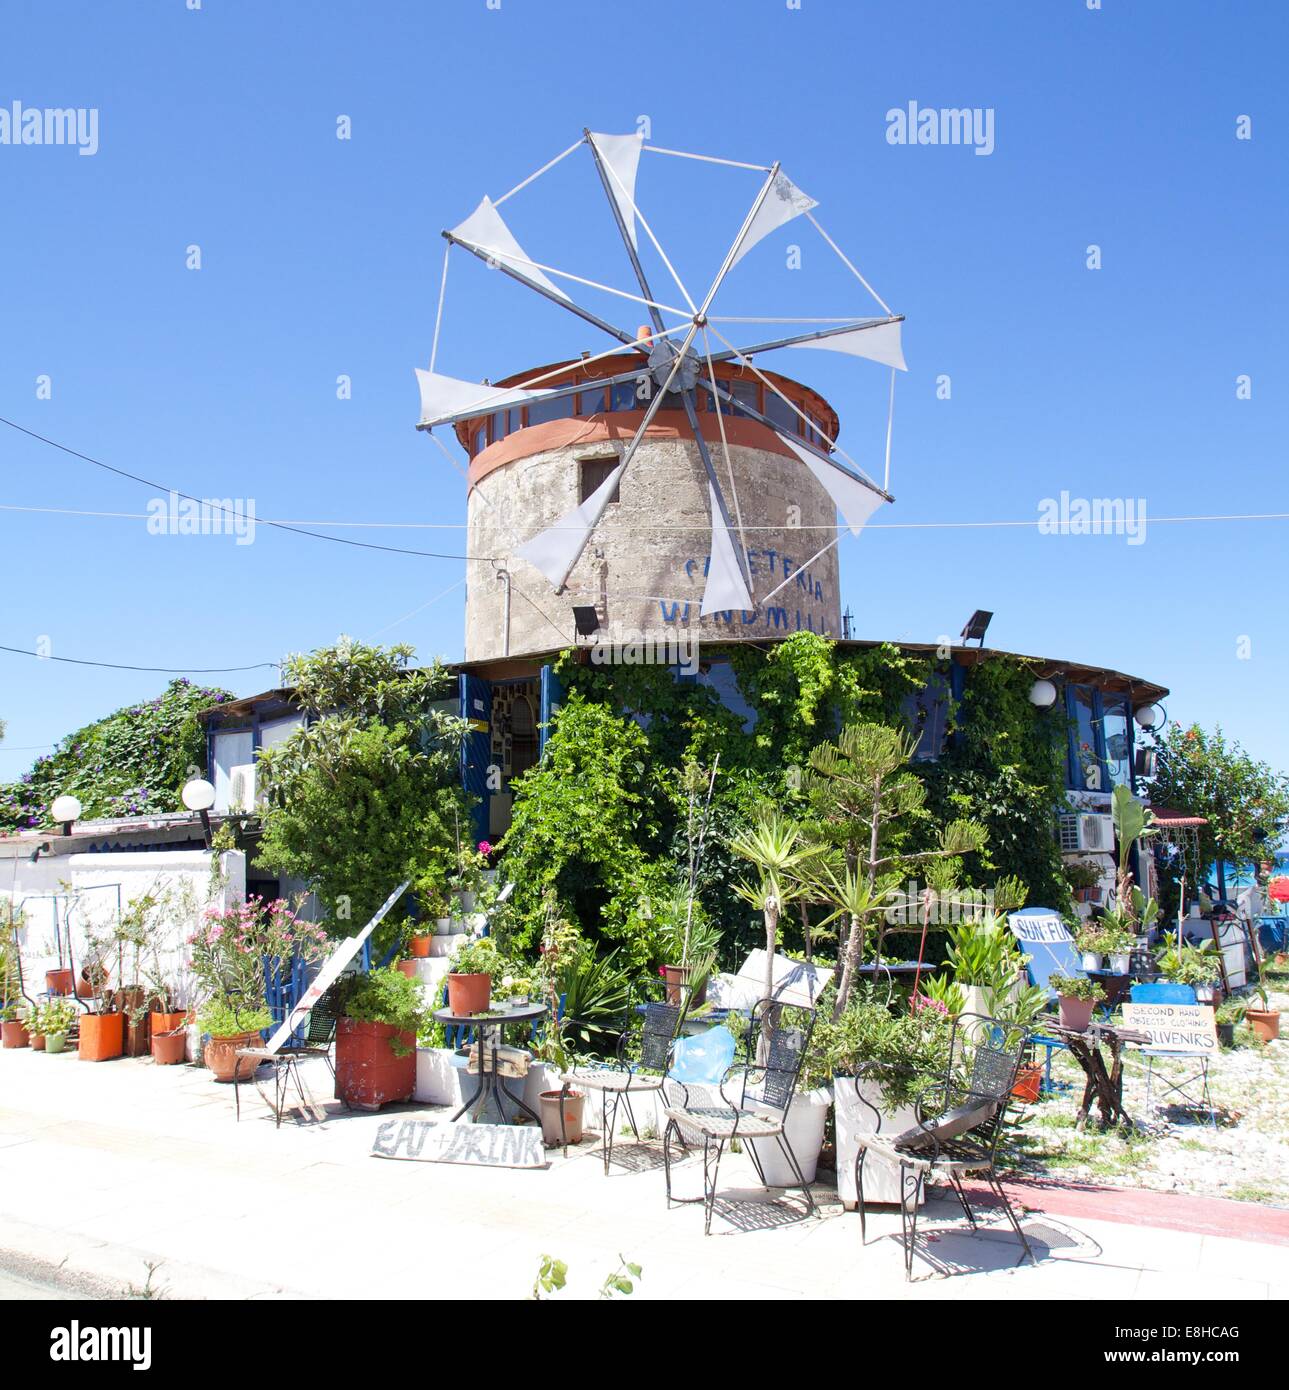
[{"left": 0, "top": 1049, "right": 1289, "bottom": 1300}]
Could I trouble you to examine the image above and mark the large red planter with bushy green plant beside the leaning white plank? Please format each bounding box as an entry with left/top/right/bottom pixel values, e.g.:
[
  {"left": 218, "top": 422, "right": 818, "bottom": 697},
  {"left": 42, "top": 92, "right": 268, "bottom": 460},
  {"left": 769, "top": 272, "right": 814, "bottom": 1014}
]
[{"left": 335, "top": 966, "right": 425, "bottom": 1111}]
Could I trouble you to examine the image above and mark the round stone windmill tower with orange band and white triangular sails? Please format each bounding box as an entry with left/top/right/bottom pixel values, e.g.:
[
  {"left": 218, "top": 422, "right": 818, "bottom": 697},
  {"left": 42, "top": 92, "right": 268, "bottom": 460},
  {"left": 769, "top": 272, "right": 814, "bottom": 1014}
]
[{"left": 417, "top": 132, "right": 904, "bottom": 660}]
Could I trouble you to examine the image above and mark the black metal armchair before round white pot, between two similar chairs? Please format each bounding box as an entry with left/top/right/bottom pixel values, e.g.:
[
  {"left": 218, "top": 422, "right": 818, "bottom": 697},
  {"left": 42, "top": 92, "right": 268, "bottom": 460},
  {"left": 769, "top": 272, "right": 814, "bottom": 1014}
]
[{"left": 662, "top": 999, "right": 815, "bottom": 1236}]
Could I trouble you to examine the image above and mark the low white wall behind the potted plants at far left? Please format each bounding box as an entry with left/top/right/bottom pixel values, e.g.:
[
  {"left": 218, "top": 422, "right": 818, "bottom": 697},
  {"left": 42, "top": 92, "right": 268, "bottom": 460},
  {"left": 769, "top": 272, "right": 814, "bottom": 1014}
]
[{"left": 0, "top": 849, "right": 246, "bottom": 1004}]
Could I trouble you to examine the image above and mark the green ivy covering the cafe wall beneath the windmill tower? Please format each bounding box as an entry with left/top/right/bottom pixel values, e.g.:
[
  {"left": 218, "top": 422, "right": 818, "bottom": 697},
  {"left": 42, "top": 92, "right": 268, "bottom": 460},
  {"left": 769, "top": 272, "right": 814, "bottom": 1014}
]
[{"left": 503, "top": 632, "right": 1069, "bottom": 965}]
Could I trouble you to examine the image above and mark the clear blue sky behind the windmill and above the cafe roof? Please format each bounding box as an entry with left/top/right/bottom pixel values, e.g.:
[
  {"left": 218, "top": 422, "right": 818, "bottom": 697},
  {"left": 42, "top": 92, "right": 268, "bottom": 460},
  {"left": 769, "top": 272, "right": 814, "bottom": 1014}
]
[{"left": 0, "top": 0, "right": 1289, "bottom": 778}]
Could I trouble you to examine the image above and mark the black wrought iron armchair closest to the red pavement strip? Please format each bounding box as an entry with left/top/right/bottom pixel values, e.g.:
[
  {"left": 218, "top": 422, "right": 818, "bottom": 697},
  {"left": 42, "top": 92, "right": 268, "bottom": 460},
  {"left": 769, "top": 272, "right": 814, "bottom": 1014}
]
[{"left": 855, "top": 1013, "right": 1039, "bottom": 1280}]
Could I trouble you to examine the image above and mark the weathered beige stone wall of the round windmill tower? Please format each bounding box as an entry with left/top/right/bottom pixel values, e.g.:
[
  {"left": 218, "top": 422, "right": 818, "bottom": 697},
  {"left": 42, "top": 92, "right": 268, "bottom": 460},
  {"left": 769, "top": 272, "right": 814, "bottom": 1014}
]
[{"left": 466, "top": 438, "right": 841, "bottom": 660}]
